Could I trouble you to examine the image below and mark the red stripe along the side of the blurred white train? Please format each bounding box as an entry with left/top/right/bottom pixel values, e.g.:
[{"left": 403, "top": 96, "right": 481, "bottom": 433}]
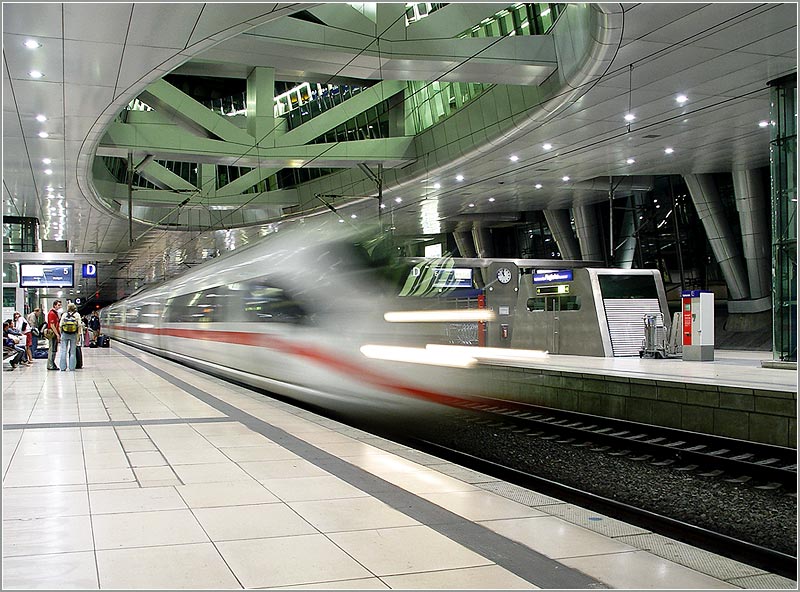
[{"left": 110, "top": 325, "right": 467, "bottom": 407}]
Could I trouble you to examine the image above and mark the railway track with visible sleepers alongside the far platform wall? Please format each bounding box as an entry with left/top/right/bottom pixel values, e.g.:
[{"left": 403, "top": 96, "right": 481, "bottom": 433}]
[{"left": 446, "top": 399, "right": 797, "bottom": 497}]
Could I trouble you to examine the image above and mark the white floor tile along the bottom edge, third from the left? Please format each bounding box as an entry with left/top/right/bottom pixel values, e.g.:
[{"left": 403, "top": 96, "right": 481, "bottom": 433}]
[{"left": 217, "top": 534, "right": 373, "bottom": 588}]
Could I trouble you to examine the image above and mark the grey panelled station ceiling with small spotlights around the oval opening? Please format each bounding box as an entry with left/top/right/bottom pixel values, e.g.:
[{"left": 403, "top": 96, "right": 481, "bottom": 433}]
[{"left": 3, "top": 2, "right": 797, "bottom": 299}]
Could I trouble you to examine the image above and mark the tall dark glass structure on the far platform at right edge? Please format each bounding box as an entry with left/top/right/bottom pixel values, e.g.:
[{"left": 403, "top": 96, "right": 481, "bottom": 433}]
[{"left": 769, "top": 74, "right": 797, "bottom": 362}]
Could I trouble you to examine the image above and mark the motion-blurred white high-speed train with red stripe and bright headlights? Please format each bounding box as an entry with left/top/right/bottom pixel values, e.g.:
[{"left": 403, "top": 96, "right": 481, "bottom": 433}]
[{"left": 101, "top": 227, "right": 500, "bottom": 410}]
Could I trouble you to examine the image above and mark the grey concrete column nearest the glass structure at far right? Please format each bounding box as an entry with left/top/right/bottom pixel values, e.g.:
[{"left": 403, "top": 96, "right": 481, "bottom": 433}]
[{"left": 733, "top": 169, "right": 772, "bottom": 300}]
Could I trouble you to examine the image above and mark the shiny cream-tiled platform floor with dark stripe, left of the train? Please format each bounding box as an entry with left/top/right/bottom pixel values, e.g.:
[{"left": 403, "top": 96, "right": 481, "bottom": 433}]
[{"left": 3, "top": 343, "right": 796, "bottom": 589}]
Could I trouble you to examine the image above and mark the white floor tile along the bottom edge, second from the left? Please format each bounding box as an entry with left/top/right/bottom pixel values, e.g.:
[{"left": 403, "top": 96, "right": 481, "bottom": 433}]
[{"left": 97, "top": 543, "right": 241, "bottom": 590}]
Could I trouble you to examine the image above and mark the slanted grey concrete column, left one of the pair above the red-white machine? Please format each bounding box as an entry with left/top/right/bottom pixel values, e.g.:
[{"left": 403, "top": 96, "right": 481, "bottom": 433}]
[{"left": 683, "top": 174, "right": 750, "bottom": 300}]
